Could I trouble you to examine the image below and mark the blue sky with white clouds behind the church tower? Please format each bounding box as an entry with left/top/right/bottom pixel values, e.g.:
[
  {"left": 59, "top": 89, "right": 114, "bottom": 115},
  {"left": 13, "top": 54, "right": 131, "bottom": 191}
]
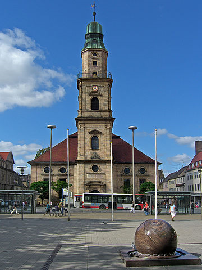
[{"left": 0, "top": 0, "right": 202, "bottom": 174}]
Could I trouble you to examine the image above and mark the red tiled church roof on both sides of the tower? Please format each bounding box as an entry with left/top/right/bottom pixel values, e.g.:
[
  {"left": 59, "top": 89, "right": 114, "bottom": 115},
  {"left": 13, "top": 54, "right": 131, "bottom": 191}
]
[{"left": 28, "top": 132, "right": 154, "bottom": 165}]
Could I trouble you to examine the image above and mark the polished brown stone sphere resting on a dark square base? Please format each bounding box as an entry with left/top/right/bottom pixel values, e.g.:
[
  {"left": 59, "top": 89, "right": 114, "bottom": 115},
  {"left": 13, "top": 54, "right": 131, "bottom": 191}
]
[{"left": 135, "top": 219, "right": 177, "bottom": 255}]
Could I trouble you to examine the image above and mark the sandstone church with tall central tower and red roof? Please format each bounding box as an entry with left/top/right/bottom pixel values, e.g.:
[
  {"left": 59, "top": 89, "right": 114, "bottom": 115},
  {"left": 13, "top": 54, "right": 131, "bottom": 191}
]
[{"left": 29, "top": 14, "right": 158, "bottom": 200}]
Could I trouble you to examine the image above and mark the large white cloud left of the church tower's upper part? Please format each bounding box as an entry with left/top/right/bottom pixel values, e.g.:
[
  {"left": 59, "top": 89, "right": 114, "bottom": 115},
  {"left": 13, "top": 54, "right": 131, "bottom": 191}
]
[{"left": 0, "top": 29, "right": 75, "bottom": 112}]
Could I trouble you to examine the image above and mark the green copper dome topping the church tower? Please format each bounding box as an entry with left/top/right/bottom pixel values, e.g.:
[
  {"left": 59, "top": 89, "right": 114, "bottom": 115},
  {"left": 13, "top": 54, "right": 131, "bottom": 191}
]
[{"left": 83, "top": 22, "right": 105, "bottom": 50}]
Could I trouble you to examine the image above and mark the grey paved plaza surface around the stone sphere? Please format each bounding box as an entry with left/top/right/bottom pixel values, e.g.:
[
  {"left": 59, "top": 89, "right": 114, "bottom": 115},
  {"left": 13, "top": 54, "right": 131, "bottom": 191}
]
[{"left": 0, "top": 209, "right": 202, "bottom": 270}]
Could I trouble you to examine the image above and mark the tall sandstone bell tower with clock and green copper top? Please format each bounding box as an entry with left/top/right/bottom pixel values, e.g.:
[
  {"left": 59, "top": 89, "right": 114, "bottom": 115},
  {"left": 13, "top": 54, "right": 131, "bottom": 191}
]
[{"left": 76, "top": 16, "right": 114, "bottom": 193}]
